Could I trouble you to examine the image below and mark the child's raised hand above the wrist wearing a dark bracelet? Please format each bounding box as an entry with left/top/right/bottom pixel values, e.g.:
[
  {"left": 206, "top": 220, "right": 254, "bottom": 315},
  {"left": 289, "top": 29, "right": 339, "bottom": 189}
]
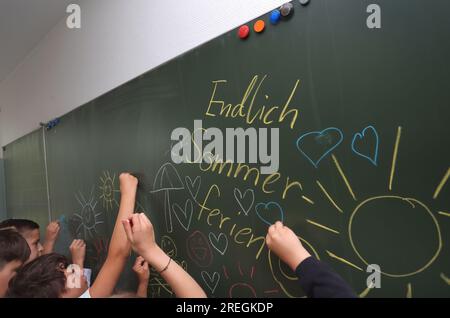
[{"left": 122, "top": 213, "right": 158, "bottom": 256}]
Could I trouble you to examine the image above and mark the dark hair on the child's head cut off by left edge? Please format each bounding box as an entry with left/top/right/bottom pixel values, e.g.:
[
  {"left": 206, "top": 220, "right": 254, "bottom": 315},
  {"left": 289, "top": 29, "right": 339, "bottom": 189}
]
[{"left": 0, "top": 229, "right": 31, "bottom": 270}]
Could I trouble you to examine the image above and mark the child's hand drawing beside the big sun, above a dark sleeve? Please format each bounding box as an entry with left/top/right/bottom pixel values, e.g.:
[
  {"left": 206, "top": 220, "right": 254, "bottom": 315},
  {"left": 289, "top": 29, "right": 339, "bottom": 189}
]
[{"left": 266, "top": 221, "right": 311, "bottom": 271}]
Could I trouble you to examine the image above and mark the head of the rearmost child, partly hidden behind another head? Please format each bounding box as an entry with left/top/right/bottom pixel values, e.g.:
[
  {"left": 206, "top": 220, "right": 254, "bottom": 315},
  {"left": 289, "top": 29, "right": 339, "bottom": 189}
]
[{"left": 0, "top": 219, "right": 43, "bottom": 262}]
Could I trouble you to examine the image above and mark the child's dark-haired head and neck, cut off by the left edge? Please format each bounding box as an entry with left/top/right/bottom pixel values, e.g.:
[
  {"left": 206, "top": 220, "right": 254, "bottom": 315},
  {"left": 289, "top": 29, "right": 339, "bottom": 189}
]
[{"left": 0, "top": 229, "right": 30, "bottom": 298}]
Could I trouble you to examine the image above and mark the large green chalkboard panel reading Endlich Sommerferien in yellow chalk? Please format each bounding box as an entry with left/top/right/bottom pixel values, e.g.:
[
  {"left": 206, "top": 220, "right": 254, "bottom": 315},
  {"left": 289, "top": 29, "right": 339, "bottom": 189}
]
[{"left": 3, "top": 0, "right": 450, "bottom": 297}]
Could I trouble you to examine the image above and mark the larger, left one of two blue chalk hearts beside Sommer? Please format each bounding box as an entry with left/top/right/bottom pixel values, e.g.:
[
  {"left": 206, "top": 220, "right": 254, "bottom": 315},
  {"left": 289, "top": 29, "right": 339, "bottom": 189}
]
[{"left": 296, "top": 127, "right": 344, "bottom": 168}]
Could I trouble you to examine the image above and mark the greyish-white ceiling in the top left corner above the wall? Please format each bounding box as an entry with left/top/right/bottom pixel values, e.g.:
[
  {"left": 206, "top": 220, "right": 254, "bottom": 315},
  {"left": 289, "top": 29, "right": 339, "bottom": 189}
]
[{"left": 0, "top": 0, "right": 78, "bottom": 82}]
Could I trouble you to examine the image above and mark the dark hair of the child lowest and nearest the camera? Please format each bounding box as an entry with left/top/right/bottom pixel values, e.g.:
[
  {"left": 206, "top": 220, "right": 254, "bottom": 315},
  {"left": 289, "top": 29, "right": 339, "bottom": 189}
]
[{"left": 7, "top": 253, "right": 68, "bottom": 298}]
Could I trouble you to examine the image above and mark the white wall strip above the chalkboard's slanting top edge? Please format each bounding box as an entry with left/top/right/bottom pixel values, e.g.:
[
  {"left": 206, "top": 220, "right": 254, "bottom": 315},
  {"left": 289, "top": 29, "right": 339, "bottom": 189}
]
[{"left": 0, "top": 0, "right": 286, "bottom": 153}]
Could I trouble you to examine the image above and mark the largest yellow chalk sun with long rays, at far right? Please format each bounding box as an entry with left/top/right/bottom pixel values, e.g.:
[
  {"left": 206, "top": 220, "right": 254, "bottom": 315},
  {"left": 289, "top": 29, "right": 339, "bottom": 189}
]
[{"left": 269, "top": 127, "right": 450, "bottom": 298}]
